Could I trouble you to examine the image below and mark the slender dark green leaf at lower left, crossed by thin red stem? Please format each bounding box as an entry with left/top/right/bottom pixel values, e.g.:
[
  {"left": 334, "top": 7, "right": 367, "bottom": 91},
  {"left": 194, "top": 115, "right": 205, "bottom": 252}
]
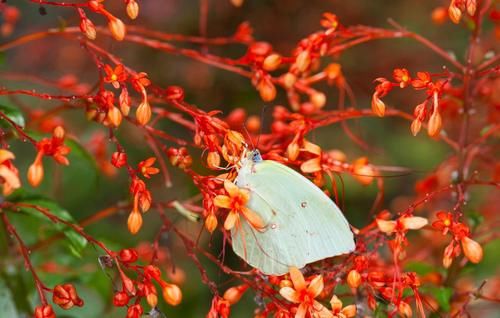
[{"left": 7, "top": 189, "right": 87, "bottom": 257}]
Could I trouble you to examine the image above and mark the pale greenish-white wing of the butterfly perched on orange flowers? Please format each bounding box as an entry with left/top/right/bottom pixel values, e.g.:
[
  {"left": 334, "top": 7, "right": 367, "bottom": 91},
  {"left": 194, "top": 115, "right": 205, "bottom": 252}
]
[{"left": 231, "top": 160, "right": 354, "bottom": 275}]
